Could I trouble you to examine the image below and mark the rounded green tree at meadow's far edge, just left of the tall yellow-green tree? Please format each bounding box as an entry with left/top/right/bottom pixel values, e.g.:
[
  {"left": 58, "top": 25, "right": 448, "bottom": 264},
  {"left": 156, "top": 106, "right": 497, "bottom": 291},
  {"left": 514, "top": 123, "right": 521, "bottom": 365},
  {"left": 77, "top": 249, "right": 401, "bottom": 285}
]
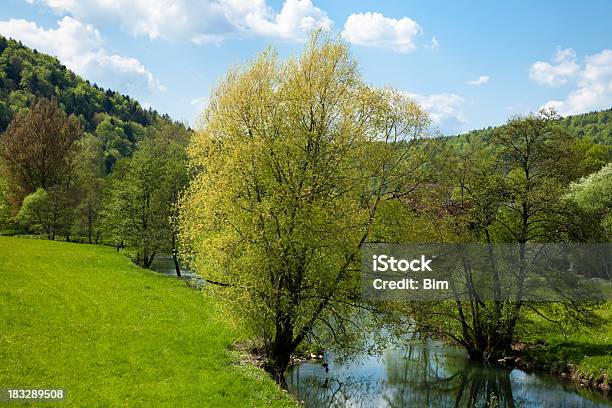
[{"left": 102, "top": 124, "right": 190, "bottom": 267}]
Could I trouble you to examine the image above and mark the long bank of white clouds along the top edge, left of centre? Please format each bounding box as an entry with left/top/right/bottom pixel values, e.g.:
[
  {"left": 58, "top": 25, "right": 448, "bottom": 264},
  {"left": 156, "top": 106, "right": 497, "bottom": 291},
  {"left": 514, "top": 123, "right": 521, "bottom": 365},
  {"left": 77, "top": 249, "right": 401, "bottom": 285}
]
[{"left": 27, "top": 0, "right": 333, "bottom": 44}]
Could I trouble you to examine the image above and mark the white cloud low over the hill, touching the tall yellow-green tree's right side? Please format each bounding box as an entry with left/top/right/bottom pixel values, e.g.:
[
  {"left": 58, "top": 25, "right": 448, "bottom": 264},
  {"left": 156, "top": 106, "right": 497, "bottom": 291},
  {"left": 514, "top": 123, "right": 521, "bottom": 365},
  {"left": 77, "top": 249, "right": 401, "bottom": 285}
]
[{"left": 407, "top": 93, "right": 468, "bottom": 134}]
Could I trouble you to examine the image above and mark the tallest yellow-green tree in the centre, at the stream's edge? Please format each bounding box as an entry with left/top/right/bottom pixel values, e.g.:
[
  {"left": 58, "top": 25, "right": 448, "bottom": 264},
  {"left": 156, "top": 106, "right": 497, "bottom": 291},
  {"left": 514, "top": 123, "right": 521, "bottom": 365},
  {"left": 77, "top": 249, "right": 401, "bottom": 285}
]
[{"left": 181, "top": 33, "right": 427, "bottom": 385}]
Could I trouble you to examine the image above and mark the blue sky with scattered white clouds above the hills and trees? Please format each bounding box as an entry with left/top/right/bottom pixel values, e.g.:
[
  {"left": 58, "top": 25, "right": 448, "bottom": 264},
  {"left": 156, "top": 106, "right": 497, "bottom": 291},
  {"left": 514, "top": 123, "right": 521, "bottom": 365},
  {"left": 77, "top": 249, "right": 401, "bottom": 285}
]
[{"left": 0, "top": 0, "right": 612, "bottom": 134}]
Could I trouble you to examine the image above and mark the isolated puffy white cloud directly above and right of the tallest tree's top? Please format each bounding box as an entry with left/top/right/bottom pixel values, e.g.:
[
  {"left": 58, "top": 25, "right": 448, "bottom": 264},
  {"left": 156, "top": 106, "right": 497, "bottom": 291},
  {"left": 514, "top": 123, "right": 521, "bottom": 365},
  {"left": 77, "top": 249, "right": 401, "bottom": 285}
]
[{"left": 342, "top": 12, "right": 420, "bottom": 53}]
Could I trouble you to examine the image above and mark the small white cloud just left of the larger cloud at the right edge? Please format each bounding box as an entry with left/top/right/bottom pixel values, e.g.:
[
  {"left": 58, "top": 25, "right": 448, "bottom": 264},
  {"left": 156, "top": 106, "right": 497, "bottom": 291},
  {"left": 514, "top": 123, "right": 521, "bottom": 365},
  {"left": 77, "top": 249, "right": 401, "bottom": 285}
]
[{"left": 529, "top": 48, "right": 580, "bottom": 86}]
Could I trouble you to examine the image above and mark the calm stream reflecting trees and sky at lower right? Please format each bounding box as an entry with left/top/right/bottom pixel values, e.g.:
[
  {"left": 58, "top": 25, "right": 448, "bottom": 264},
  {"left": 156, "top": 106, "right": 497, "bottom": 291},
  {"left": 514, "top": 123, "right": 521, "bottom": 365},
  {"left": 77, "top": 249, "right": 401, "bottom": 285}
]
[{"left": 287, "top": 340, "right": 612, "bottom": 408}]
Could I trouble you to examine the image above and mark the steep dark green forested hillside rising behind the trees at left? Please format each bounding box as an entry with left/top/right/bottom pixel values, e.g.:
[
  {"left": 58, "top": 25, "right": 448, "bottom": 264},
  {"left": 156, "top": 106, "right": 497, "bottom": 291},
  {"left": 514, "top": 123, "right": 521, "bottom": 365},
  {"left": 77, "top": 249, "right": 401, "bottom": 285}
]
[{"left": 0, "top": 35, "right": 183, "bottom": 171}]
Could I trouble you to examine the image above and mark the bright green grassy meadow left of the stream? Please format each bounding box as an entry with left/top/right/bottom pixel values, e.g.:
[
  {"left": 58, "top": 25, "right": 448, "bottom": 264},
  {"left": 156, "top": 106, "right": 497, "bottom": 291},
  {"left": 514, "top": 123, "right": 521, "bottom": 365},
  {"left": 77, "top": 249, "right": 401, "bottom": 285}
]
[{"left": 0, "top": 237, "right": 295, "bottom": 407}]
